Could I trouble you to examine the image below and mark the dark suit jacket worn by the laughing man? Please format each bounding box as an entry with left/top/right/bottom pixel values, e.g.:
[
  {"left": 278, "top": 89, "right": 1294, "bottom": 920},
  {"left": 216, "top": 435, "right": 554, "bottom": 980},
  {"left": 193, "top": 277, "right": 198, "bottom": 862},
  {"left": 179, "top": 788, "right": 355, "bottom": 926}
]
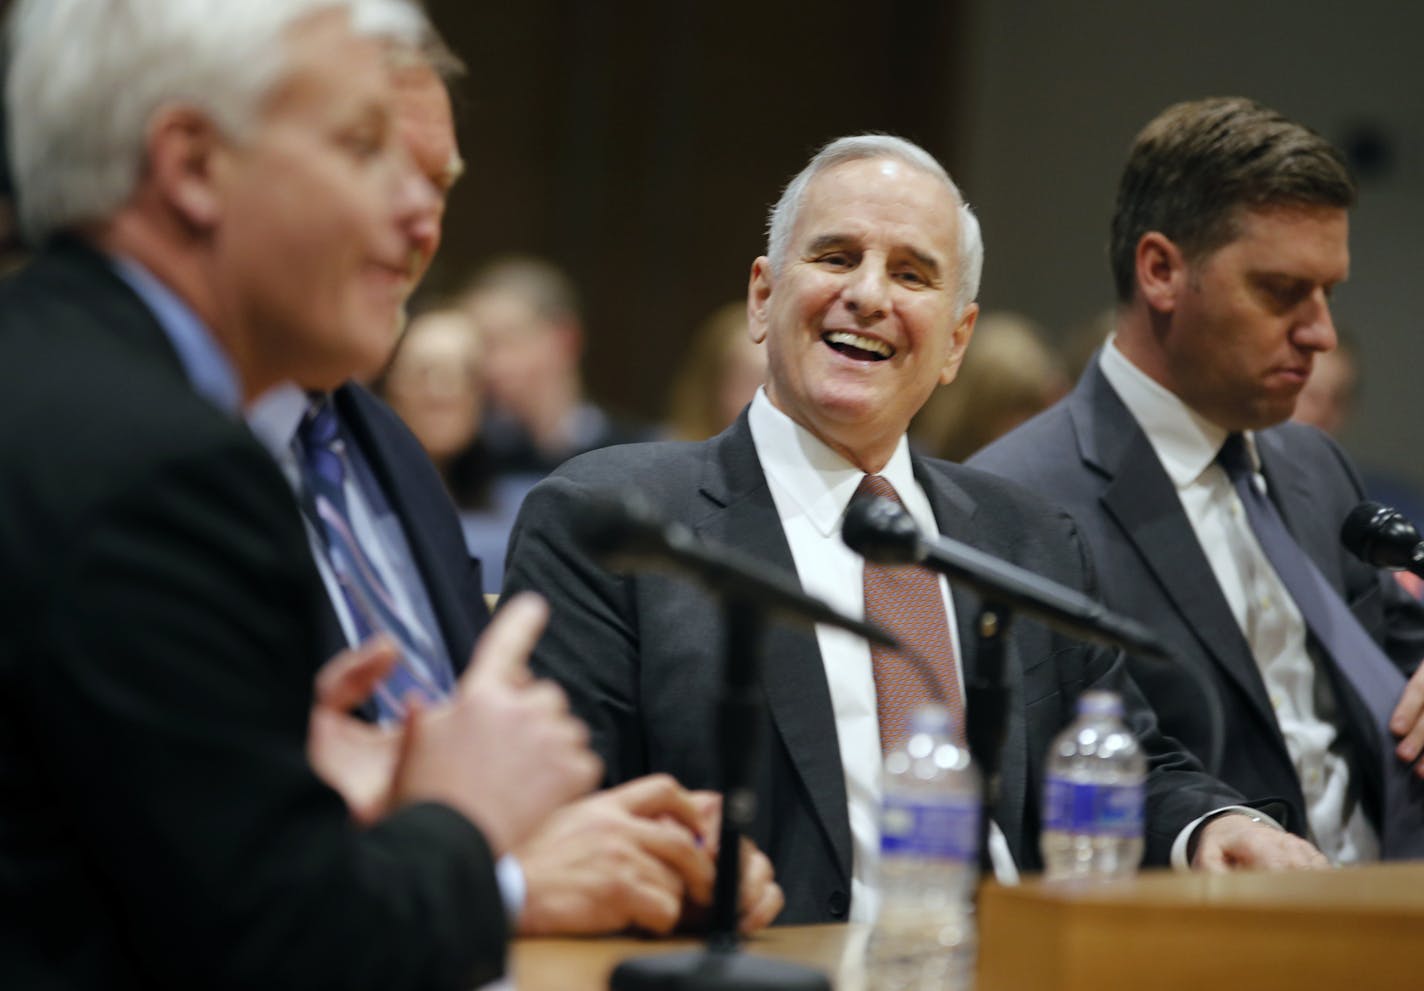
[{"left": 504, "top": 413, "right": 1240, "bottom": 923}]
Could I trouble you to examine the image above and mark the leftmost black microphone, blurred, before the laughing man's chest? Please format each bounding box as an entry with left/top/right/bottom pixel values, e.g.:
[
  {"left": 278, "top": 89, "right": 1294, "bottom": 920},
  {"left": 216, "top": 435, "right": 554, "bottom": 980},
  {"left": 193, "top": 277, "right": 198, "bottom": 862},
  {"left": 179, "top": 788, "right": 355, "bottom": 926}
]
[{"left": 574, "top": 491, "right": 899, "bottom": 648}]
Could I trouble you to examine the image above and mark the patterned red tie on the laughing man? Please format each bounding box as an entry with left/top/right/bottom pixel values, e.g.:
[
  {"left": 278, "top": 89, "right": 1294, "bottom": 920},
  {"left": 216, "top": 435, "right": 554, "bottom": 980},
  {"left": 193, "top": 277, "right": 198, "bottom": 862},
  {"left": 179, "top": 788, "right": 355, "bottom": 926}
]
[{"left": 856, "top": 476, "right": 964, "bottom": 753}]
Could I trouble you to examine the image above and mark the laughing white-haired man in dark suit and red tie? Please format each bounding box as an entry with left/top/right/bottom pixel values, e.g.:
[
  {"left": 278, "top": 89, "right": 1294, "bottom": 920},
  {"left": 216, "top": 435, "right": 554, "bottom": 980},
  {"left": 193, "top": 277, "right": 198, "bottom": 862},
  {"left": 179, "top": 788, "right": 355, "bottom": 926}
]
[{"left": 506, "top": 135, "right": 1320, "bottom": 923}]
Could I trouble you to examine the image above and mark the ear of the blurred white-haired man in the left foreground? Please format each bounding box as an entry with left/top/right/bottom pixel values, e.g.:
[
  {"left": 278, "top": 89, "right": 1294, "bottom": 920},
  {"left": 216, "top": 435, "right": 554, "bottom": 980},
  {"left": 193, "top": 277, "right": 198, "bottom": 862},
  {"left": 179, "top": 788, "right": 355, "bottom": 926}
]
[{"left": 147, "top": 107, "right": 228, "bottom": 229}]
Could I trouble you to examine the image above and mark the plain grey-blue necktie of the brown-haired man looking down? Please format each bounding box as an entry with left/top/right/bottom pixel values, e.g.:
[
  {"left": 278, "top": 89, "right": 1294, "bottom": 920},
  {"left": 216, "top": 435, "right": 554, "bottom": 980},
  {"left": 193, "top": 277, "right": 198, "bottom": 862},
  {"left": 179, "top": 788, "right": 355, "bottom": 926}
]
[{"left": 1216, "top": 433, "right": 1424, "bottom": 860}]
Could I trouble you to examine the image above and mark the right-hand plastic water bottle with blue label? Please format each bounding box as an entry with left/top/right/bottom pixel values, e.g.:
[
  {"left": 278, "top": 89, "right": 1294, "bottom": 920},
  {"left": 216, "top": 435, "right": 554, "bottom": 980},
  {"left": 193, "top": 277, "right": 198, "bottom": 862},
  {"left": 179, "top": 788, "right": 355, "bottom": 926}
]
[{"left": 1042, "top": 692, "right": 1146, "bottom": 880}]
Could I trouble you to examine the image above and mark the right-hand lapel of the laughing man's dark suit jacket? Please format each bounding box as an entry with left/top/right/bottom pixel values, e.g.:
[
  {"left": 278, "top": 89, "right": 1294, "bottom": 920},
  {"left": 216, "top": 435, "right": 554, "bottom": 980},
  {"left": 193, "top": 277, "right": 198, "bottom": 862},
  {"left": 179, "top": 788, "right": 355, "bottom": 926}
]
[{"left": 914, "top": 457, "right": 1028, "bottom": 863}]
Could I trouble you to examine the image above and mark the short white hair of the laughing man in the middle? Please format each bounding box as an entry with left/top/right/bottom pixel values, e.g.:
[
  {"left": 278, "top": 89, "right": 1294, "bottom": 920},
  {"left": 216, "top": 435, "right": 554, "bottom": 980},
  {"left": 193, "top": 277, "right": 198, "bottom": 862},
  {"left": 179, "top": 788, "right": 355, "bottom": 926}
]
[{"left": 766, "top": 134, "right": 984, "bottom": 313}]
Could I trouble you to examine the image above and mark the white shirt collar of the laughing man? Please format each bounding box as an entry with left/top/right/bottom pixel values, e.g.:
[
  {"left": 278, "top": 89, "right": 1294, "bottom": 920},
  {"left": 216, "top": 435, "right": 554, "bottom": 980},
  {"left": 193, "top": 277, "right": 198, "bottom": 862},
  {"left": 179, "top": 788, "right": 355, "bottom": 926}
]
[{"left": 746, "top": 389, "right": 938, "bottom": 537}]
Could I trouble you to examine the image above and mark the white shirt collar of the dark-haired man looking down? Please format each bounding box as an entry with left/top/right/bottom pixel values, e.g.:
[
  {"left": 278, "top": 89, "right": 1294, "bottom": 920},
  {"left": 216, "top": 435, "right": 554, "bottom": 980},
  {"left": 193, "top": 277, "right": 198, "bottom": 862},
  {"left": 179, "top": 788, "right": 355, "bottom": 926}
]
[{"left": 1098, "top": 335, "right": 1260, "bottom": 490}]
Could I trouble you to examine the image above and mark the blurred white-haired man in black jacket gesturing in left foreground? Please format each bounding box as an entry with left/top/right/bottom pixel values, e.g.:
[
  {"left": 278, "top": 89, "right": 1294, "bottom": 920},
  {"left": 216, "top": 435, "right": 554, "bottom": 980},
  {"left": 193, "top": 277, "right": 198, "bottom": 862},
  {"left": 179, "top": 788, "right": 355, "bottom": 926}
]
[{"left": 0, "top": 0, "right": 598, "bottom": 988}]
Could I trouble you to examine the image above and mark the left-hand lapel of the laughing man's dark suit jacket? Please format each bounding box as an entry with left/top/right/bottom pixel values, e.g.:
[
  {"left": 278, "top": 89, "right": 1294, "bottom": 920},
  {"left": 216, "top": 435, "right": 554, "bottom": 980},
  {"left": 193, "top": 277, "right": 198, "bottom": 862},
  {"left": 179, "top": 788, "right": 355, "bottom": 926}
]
[{"left": 693, "top": 411, "right": 852, "bottom": 883}]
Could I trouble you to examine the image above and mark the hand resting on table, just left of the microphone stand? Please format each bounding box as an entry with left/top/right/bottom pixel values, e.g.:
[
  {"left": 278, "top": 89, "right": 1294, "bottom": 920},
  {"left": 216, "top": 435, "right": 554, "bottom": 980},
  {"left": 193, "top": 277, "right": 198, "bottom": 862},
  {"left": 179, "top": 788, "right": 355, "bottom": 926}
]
[{"left": 514, "top": 775, "right": 713, "bottom": 935}]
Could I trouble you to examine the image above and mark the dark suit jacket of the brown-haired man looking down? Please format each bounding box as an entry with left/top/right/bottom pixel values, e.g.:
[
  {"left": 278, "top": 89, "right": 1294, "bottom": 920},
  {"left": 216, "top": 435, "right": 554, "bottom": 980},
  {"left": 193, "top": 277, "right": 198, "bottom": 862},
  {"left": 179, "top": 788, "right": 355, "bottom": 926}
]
[{"left": 970, "top": 362, "right": 1424, "bottom": 834}]
